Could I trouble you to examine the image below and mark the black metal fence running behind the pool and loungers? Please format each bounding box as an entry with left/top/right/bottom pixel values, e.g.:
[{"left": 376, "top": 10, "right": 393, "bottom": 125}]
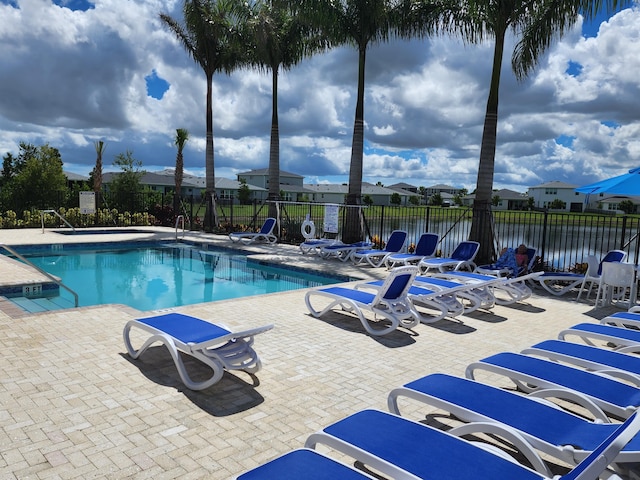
[{"left": 0, "top": 192, "right": 640, "bottom": 271}]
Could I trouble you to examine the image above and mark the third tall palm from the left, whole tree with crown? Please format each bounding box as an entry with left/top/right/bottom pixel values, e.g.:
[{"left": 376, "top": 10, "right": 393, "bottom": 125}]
[{"left": 301, "top": 0, "right": 406, "bottom": 242}]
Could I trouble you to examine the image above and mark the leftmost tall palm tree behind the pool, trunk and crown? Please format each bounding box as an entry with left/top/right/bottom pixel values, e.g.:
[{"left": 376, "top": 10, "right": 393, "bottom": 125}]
[{"left": 160, "top": 0, "right": 249, "bottom": 231}]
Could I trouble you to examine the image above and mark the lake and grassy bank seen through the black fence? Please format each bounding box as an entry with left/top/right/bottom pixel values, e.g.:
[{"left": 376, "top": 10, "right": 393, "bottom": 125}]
[{"left": 228, "top": 202, "right": 640, "bottom": 271}]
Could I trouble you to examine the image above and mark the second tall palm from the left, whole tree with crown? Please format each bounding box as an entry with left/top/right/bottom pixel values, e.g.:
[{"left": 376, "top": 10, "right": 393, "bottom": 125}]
[{"left": 249, "top": 0, "right": 321, "bottom": 217}]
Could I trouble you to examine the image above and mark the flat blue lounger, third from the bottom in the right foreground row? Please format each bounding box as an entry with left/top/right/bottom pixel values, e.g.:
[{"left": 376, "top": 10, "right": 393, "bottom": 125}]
[{"left": 387, "top": 374, "right": 640, "bottom": 473}]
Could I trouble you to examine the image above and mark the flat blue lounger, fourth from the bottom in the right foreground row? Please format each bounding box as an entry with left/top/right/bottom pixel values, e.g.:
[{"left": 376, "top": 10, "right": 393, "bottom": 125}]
[{"left": 465, "top": 352, "right": 640, "bottom": 418}]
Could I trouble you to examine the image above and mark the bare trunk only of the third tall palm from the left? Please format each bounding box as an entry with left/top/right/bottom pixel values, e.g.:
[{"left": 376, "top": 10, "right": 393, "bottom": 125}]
[{"left": 342, "top": 47, "right": 367, "bottom": 243}]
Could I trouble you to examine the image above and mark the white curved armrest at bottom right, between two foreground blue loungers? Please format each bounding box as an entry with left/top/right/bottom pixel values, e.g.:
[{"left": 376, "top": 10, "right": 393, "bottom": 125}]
[{"left": 449, "top": 422, "right": 553, "bottom": 478}]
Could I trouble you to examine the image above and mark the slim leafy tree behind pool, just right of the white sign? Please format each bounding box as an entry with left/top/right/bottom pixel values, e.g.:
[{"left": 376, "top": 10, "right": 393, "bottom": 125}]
[{"left": 109, "top": 150, "right": 146, "bottom": 213}]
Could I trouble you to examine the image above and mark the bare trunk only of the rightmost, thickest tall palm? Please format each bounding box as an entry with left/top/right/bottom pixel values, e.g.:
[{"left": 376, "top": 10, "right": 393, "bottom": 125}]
[{"left": 469, "top": 31, "right": 505, "bottom": 264}]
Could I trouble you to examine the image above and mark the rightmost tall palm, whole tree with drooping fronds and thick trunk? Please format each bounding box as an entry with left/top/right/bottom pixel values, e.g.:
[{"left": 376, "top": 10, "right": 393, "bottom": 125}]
[{"left": 450, "top": 0, "right": 627, "bottom": 263}]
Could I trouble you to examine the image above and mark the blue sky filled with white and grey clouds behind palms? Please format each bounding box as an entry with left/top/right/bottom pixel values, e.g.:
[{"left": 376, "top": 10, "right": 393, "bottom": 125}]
[{"left": 0, "top": 0, "right": 640, "bottom": 192}]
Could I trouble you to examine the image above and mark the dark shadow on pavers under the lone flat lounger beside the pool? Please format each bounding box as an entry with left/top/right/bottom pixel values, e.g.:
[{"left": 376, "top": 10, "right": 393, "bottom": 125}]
[{"left": 120, "top": 345, "right": 264, "bottom": 417}]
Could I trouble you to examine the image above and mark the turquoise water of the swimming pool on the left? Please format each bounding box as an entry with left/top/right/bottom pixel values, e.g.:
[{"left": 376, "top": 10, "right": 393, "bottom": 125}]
[{"left": 6, "top": 243, "right": 348, "bottom": 310}]
